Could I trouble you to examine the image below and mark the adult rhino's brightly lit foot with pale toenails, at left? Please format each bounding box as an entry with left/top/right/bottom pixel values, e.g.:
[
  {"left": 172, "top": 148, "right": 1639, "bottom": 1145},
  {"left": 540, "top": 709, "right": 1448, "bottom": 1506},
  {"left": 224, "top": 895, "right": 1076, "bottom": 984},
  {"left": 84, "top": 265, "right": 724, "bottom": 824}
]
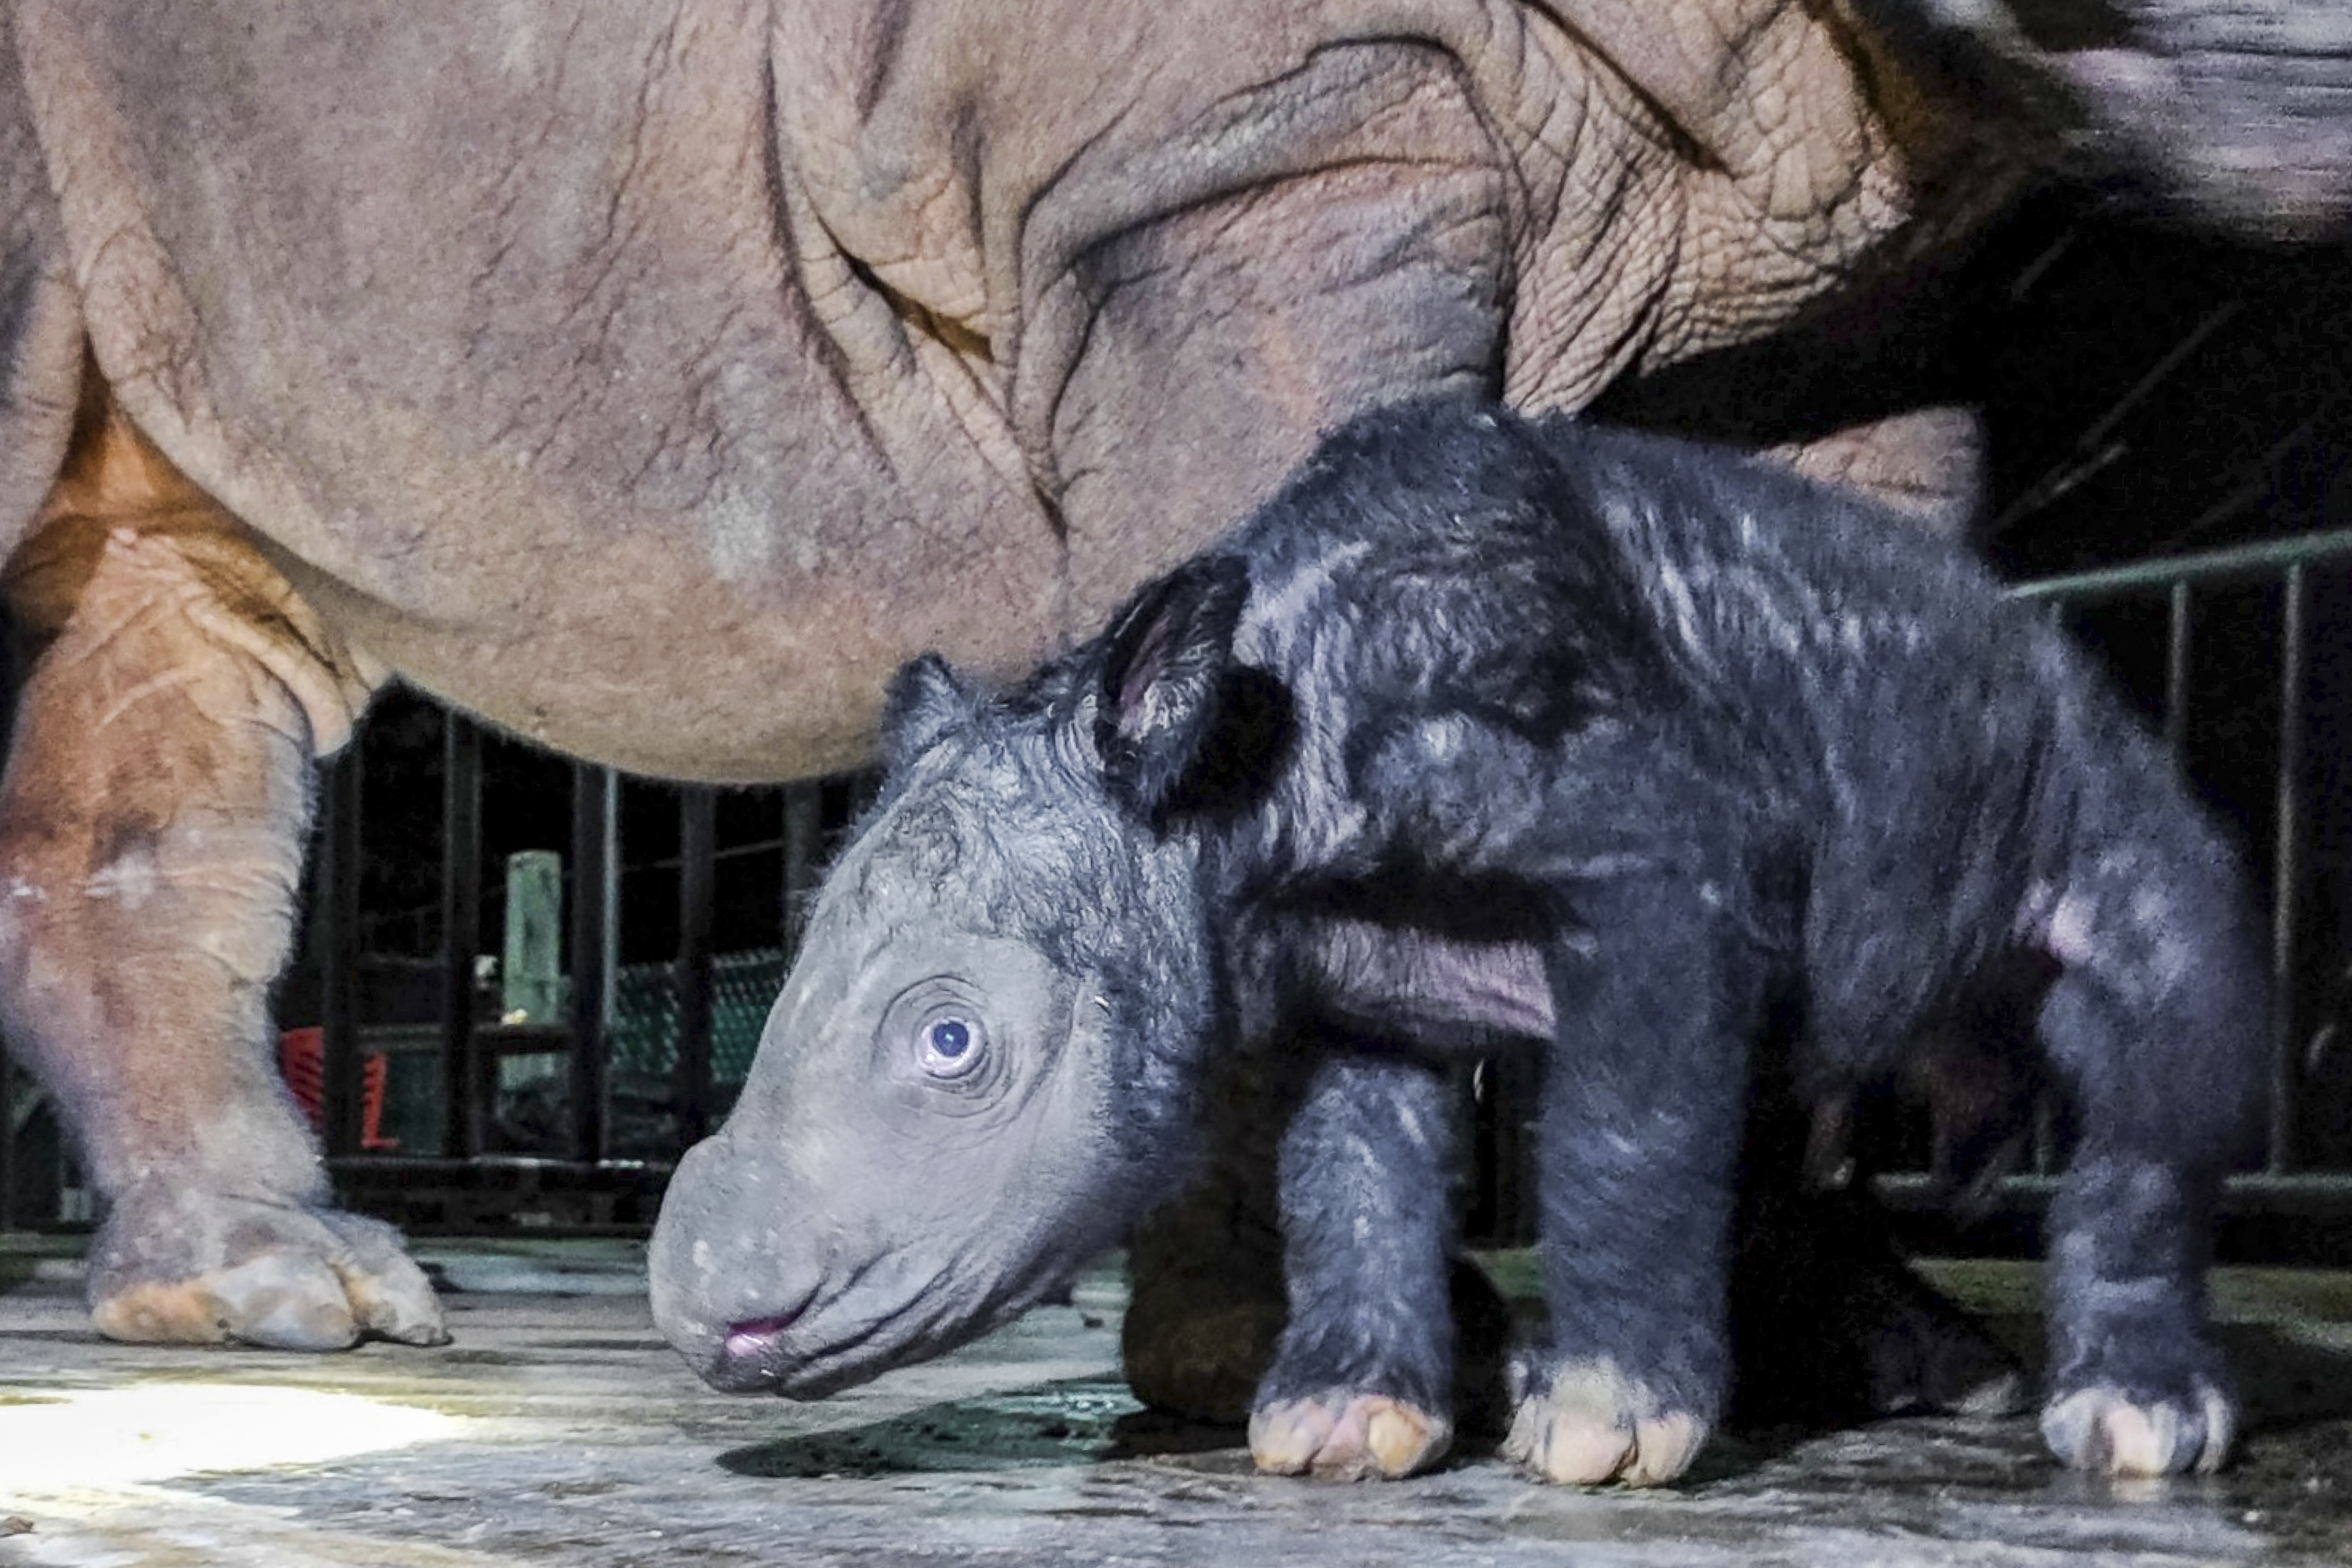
[{"left": 89, "top": 1185, "right": 449, "bottom": 1349}]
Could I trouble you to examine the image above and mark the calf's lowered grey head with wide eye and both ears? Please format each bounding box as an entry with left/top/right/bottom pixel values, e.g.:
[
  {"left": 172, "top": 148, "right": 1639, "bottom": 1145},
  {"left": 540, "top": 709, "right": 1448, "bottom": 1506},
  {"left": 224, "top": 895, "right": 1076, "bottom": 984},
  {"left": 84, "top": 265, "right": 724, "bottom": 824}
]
[{"left": 649, "top": 564, "right": 1246, "bottom": 1399}]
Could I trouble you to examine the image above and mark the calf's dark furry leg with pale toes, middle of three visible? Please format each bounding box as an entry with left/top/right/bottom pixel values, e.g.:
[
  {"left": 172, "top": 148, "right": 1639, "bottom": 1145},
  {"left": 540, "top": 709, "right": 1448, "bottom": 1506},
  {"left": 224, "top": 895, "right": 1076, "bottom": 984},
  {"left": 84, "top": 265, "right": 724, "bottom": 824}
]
[{"left": 1503, "top": 872, "right": 1762, "bottom": 1486}]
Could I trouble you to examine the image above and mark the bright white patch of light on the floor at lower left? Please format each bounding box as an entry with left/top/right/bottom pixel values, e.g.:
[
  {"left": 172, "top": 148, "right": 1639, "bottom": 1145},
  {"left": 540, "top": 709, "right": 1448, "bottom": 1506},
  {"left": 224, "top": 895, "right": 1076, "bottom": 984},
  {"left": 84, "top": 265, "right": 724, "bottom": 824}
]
[{"left": 0, "top": 1382, "right": 463, "bottom": 1490}]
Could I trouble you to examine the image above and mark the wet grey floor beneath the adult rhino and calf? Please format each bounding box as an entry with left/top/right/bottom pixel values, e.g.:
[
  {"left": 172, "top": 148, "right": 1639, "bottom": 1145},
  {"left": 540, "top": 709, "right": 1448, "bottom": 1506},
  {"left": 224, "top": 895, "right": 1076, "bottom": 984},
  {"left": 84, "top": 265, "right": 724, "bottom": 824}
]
[{"left": 0, "top": 1244, "right": 2352, "bottom": 1568}]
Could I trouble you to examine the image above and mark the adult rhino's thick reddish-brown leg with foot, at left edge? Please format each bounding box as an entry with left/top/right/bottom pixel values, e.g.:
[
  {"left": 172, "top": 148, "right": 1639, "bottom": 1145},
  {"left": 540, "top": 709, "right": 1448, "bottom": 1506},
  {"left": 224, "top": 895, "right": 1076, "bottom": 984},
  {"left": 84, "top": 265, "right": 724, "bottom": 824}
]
[{"left": 0, "top": 409, "right": 449, "bottom": 1349}]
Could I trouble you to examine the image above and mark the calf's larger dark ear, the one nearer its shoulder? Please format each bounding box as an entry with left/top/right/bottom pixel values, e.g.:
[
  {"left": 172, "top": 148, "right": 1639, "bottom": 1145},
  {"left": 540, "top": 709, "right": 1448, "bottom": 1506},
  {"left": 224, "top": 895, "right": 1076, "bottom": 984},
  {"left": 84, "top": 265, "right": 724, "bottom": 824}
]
[{"left": 1094, "top": 555, "right": 1272, "bottom": 827}]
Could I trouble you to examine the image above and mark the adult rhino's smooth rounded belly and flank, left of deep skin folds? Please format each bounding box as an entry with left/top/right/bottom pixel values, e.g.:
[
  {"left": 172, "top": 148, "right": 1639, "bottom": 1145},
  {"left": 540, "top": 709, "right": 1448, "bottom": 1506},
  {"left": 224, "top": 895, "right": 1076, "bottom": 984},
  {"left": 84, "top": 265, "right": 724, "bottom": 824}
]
[{"left": 19, "top": 5, "right": 1066, "bottom": 780}]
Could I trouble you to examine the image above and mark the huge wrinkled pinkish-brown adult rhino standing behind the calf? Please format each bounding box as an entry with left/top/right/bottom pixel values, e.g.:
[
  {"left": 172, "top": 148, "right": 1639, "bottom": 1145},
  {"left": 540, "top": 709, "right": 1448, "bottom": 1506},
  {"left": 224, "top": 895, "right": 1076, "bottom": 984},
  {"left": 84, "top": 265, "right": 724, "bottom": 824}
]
[{"left": 0, "top": 0, "right": 2352, "bottom": 1347}]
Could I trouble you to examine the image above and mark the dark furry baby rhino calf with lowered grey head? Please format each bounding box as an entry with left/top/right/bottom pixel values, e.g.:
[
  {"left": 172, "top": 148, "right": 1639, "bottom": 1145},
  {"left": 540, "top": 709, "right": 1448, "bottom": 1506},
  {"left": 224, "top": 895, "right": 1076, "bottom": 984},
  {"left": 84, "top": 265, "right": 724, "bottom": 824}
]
[{"left": 652, "top": 402, "right": 2267, "bottom": 1483}]
